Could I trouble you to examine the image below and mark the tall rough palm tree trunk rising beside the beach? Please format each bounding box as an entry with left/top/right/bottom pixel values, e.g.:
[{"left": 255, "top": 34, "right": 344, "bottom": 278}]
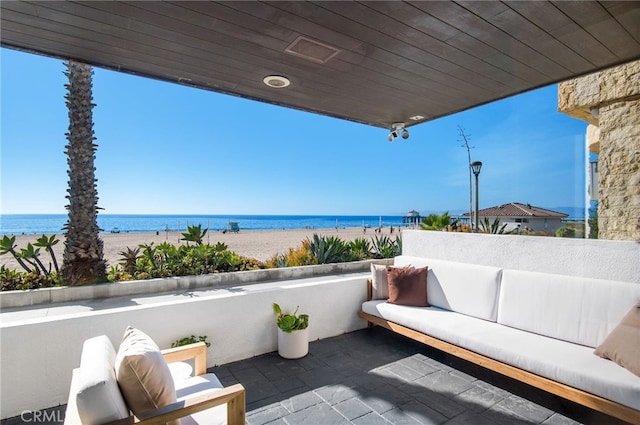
[{"left": 62, "top": 61, "right": 107, "bottom": 285}]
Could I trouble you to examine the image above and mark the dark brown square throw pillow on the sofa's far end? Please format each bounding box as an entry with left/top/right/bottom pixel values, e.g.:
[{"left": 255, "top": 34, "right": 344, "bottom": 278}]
[{"left": 387, "top": 267, "right": 428, "bottom": 307}]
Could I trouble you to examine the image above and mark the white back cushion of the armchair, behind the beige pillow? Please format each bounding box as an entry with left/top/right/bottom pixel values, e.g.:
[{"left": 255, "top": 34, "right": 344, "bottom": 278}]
[{"left": 74, "top": 335, "right": 129, "bottom": 425}]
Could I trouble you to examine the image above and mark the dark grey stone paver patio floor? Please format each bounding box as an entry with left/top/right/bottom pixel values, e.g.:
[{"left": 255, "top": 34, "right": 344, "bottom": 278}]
[{"left": 209, "top": 327, "right": 621, "bottom": 425}]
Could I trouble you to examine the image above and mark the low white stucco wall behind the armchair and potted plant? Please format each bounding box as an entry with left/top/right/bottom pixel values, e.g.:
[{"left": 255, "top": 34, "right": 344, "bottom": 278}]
[{"left": 0, "top": 273, "right": 368, "bottom": 418}]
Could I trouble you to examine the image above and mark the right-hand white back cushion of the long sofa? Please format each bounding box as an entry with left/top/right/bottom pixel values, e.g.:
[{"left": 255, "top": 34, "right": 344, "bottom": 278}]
[{"left": 498, "top": 269, "right": 640, "bottom": 348}]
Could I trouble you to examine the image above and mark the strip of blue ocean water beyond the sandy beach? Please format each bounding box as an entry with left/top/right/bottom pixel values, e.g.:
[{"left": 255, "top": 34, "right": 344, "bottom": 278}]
[{"left": 0, "top": 214, "right": 402, "bottom": 235}]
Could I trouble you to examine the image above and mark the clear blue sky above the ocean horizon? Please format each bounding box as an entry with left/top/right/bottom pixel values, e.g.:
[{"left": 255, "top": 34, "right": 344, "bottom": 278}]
[{"left": 0, "top": 49, "right": 586, "bottom": 215}]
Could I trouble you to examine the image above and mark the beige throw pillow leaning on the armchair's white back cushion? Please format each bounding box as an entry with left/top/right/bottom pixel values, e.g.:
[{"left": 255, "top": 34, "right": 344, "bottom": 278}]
[{"left": 115, "top": 326, "right": 180, "bottom": 425}]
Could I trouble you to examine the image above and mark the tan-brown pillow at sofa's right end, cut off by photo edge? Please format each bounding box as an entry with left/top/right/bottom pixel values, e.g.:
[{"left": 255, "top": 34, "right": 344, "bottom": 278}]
[{"left": 595, "top": 303, "right": 640, "bottom": 376}]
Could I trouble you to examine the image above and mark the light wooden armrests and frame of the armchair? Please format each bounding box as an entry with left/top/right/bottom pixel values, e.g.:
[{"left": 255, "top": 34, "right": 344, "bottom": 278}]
[{"left": 106, "top": 342, "right": 246, "bottom": 425}]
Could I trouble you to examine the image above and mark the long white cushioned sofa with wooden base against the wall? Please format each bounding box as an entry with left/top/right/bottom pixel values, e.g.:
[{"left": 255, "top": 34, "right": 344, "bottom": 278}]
[{"left": 360, "top": 256, "right": 640, "bottom": 423}]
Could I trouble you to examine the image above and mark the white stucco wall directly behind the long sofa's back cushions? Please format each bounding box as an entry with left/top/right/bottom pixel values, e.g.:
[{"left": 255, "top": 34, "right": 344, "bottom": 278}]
[{"left": 402, "top": 230, "right": 640, "bottom": 283}]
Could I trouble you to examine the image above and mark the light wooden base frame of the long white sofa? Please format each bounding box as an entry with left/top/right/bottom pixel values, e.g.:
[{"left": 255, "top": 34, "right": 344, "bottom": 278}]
[{"left": 358, "top": 280, "right": 640, "bottom": 424}]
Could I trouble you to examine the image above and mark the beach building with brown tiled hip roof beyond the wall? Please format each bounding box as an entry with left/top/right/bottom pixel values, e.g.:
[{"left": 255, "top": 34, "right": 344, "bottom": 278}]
[{"left": 462, "top": 202, "right": 569, "bottom": 234}]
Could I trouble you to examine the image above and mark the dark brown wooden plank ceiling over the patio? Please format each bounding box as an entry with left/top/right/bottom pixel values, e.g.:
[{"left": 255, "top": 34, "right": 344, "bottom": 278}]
[{"left": 0, "top": 1, "right": 640, "bottom": 128}]
